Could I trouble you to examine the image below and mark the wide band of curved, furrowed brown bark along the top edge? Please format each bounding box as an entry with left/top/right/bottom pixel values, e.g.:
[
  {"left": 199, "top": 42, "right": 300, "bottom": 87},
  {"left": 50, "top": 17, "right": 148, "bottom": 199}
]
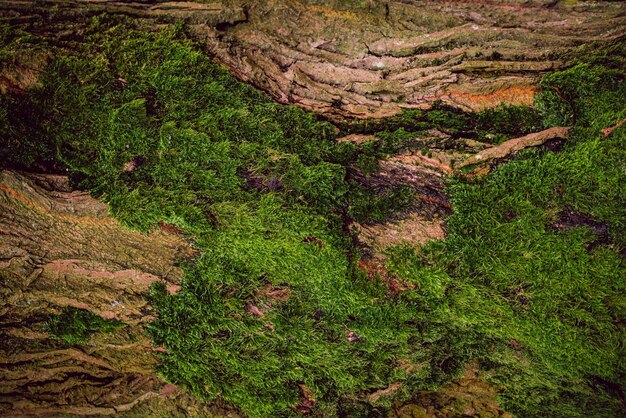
[{"left": 0, "top": 0, "right": 626, "bottom": 119}]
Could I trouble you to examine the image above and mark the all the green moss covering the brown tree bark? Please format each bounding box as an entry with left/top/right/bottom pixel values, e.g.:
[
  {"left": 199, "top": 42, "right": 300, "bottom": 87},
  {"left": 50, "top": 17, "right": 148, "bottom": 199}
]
[{"left": 0, "top": 16, "right": 626, "bottom": 417}]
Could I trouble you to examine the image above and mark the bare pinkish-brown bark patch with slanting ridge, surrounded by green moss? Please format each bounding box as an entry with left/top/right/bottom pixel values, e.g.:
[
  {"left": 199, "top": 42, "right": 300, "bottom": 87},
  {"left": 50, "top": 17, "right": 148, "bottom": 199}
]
[{"left": 346, "top": 127, "right": 570, "bottom": 261}]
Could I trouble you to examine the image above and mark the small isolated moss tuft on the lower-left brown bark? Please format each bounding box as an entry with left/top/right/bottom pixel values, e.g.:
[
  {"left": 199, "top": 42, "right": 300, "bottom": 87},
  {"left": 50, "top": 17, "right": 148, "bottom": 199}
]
[{"left": 46, "top": 308, "right": 125, "bottom": 346}]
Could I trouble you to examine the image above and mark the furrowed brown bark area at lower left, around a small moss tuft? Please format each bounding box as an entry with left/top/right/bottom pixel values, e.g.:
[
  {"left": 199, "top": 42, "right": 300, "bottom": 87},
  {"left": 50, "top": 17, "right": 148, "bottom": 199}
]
[{"left": 0, "top": 170, "right": 232, "bottom": 416}]
